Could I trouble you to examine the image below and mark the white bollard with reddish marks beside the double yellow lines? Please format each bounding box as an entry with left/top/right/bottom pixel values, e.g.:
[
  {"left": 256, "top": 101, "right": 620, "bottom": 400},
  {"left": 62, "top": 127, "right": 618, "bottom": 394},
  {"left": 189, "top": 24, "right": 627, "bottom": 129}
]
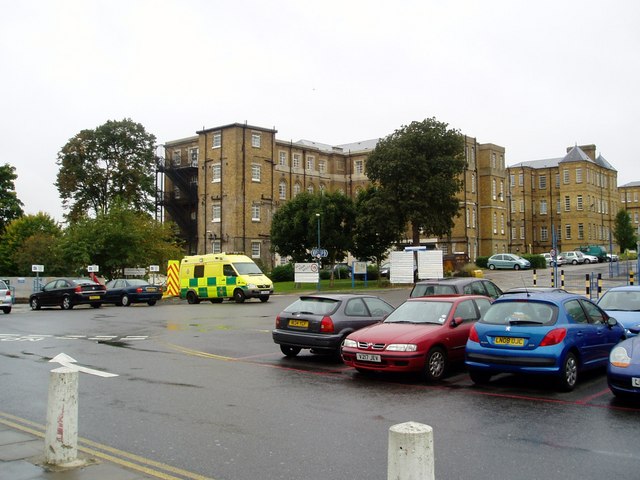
[{"left": 44, "top": 367, "right": 78, "bottom": 466}]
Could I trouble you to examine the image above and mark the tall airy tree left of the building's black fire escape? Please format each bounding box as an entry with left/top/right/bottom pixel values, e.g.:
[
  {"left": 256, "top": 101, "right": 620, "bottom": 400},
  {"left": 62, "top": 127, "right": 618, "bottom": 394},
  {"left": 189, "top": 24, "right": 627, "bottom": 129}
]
[{"left": 56, "top": 119, "right": 156, "bottom": 221}]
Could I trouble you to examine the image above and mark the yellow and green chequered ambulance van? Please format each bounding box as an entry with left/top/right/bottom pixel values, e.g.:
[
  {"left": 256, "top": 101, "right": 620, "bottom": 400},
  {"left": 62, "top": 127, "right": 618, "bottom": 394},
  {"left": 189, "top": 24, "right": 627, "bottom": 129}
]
[{"left": 180, "top": 253, "right": 273, "bottom": 304}]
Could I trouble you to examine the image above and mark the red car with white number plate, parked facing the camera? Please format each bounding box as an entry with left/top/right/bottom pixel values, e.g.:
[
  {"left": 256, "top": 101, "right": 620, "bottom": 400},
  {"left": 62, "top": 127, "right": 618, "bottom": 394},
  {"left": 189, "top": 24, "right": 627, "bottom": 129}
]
[{"left": 341, "top": 295, "right": 491, "bottom": 381}]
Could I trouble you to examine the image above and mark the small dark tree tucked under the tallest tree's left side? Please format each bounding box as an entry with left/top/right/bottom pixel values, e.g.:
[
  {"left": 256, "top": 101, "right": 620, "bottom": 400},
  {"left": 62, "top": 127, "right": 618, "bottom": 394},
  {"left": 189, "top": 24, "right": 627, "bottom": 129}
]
[{"left": 351, "top": 186, "right": 404, "bottom": 269}]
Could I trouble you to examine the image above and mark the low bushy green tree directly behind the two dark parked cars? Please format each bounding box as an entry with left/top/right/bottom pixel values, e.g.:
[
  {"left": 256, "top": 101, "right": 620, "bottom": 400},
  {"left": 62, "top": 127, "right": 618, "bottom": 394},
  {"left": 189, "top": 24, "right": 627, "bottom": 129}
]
[{"left": 62, "top": 203, "right": 183, "bottom": 279}]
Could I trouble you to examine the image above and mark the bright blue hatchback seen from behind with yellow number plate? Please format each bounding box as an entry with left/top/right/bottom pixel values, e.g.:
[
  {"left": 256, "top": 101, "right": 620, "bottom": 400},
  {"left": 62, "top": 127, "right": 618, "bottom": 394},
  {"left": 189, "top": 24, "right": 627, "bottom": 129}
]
[{"left": 465, "top": 293, "right": 625, "bottom": 391}]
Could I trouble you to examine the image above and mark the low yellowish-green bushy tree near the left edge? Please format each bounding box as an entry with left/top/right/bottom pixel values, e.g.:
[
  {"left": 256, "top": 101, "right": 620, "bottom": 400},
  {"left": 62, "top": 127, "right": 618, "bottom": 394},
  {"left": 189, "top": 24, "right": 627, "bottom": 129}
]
[{"left": 0, "top": 212, "right": 62, "bottom": 276}]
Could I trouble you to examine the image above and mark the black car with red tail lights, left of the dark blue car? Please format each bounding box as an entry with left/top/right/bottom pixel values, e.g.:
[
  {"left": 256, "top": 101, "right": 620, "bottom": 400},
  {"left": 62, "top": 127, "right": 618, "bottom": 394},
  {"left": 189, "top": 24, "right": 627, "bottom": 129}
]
[{"left": 29, "top": 278, "right": 106, "bottom": 310}]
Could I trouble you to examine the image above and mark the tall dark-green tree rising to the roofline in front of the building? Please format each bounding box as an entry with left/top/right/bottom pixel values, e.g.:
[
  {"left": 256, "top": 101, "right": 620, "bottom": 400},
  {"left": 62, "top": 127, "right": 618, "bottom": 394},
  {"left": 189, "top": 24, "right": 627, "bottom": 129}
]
[{"left": 366, "top": 118, "right": 465, "bottom": 245}]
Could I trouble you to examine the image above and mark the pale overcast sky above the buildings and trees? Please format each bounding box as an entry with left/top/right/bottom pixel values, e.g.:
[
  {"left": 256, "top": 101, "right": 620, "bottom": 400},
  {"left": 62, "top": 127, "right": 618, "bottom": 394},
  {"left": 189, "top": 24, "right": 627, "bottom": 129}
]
[{"left": 0, "top": 0, "right": 640, "bottom": 220}]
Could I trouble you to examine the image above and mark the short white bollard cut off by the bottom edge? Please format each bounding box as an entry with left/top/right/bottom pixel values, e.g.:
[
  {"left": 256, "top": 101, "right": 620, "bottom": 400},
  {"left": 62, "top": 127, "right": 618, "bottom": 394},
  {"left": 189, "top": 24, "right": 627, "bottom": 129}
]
[{"left": 387, "top": 422, "right": 435, "bottom": 480}]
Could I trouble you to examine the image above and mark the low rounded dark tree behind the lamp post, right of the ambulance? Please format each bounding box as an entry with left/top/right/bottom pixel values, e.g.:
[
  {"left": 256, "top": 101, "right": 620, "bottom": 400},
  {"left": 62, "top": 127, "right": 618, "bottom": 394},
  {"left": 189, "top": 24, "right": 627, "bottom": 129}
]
[{"left": 271, "top": 192, "right": 355, "bottom": 272}]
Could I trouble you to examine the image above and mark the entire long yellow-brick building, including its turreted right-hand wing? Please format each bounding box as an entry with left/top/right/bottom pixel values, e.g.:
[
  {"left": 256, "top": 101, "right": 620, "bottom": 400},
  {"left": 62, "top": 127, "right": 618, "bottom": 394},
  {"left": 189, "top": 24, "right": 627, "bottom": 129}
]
[{"left": 159, "top": 123, "right": 618, "bottom": 265}]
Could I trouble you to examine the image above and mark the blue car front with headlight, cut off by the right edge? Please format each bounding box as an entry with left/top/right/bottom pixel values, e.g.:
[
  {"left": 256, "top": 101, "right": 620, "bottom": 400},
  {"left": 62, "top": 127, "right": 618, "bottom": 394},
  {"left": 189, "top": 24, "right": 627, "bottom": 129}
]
[{"left": 607, "top": 328, "right": 640, "bottom": 400}]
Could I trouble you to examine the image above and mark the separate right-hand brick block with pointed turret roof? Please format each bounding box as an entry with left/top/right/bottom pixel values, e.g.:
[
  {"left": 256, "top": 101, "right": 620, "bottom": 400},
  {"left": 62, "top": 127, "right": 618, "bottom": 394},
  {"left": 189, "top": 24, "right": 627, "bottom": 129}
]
[{"left": 508, "top": 145, "right": 619, "bottom": 253}]
